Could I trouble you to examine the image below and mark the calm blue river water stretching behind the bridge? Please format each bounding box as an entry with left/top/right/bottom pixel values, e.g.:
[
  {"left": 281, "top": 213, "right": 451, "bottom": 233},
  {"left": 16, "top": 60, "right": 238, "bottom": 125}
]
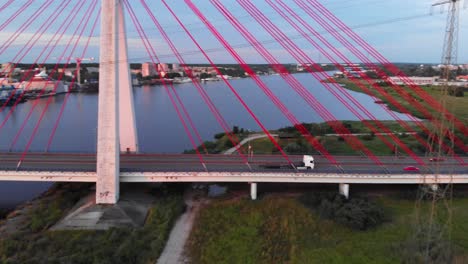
[{"left": 0, "top": 74, "right": 414, "bottom": 207}]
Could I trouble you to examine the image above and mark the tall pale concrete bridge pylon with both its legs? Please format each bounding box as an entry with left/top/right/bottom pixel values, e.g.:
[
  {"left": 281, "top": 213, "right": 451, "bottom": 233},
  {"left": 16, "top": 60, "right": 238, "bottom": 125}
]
[{"left": 96, "top": 0, "right": 138, "bottom": 204}]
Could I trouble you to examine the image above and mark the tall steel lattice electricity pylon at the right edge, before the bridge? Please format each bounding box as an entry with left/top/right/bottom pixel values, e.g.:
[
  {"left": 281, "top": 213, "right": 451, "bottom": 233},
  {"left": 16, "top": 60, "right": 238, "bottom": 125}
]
[{"left": 414, "top": 0, "right": 462, "bottom": 263}]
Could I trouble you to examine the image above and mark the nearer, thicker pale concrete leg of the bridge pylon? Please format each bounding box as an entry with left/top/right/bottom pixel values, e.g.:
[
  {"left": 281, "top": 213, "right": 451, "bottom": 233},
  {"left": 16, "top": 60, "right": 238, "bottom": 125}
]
[{"left": 96, "top": 0, "right": 120, "bottom": 204}]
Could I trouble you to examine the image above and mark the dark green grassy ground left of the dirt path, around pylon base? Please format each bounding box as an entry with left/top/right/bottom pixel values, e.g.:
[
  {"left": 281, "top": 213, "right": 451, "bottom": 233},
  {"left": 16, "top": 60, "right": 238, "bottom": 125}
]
[{"left": 0, "top": 184, "right": 185, "bottom": 264}]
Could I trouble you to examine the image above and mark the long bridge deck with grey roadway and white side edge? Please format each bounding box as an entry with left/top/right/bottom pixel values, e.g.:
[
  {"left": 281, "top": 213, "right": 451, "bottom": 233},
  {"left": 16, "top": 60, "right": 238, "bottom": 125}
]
[{"left": 0, "top": 153, "right": 468, "bottom": 184}]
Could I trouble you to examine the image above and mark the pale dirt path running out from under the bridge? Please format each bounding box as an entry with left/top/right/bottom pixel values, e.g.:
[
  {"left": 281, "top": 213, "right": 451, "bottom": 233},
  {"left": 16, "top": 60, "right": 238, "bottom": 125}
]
[{"left": 157, "top": 191, "right": 206, "bottom": 264}]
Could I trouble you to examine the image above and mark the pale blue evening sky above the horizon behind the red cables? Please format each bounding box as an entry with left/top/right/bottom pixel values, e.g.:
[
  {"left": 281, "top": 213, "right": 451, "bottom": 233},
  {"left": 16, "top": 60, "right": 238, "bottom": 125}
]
[{"left": 0, "top": 0, "right": 468, "bottom": 64}]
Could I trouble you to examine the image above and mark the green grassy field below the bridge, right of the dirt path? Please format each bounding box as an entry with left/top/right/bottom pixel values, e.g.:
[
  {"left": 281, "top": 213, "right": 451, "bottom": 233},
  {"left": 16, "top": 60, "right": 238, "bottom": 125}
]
[{"left": 189, "top": 196, "right": 468, "bottom": 264}]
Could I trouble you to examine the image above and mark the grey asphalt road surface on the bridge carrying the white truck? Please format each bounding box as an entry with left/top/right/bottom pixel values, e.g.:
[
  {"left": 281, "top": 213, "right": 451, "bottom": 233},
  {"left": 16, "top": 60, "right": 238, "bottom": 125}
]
[{"left": 0, "top": 153, "right": 468, "bottom": 174}]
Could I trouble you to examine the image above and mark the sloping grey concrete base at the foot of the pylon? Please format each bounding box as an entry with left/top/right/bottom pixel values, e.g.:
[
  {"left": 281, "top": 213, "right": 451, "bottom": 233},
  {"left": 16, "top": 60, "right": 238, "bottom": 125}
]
[{"left": 51, "top": 190, "right": 155, "bottom": 230}]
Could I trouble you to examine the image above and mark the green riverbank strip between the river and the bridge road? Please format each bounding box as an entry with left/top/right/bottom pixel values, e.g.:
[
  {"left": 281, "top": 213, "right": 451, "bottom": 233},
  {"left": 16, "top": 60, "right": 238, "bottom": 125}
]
[{"left": 186, "top": 121, "right": 468, "bottom": 156}]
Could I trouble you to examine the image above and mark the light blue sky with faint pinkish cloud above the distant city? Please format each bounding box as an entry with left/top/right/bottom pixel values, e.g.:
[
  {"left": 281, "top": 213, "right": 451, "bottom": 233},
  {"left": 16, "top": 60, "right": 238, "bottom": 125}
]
[{"left": 0, "top": 0, "right": 468, "bottom": 64}]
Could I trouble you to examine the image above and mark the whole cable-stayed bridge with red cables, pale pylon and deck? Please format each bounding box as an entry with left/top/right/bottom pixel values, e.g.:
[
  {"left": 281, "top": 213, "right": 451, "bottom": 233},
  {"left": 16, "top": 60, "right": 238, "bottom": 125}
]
[{"left": 0, "top": 0, "right": 468, "bottom": 204}]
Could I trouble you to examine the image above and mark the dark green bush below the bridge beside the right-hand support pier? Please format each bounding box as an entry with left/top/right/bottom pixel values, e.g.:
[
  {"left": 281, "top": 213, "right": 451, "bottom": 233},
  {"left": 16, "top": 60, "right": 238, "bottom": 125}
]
[{"left": 300, "top": 193, "right": 385, "bottom": 230}]
